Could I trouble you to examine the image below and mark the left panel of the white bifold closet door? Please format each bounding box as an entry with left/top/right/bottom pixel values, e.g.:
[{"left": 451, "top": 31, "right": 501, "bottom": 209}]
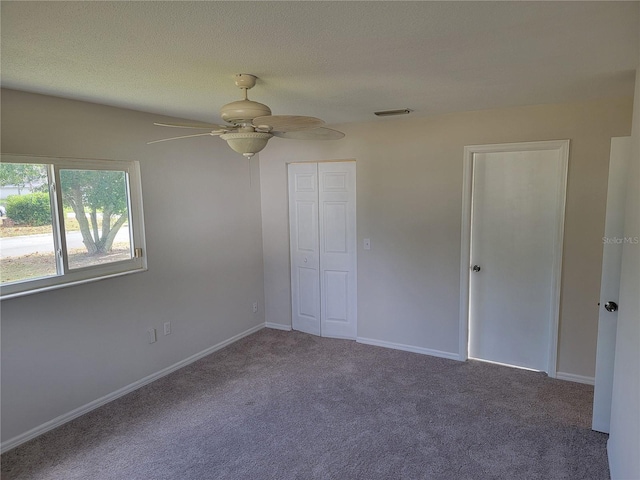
[{"left": 289, "top": 163, "right": 320, "bottom": 335}]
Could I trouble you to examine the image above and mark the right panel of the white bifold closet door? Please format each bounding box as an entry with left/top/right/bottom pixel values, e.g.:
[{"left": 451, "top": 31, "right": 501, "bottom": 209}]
[{"left": 318, "top": 162, "right": 357, "bottom": 338}]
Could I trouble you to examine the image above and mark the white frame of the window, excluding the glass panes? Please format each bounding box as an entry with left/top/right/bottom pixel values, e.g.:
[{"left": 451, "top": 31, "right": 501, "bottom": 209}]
[{"left": 0, "top": 153, "right": 147, "bottom": 300}]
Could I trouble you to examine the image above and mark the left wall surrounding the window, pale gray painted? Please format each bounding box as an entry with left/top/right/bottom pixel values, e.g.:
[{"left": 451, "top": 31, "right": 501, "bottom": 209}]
[{"left": 1, "top": 90, "right": 264, "bottom": 442}]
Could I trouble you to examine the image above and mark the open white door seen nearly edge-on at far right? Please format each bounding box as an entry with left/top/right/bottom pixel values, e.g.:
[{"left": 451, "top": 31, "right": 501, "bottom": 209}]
[{"left": 592, "top": 137, "right": 631, "bottom": 433}]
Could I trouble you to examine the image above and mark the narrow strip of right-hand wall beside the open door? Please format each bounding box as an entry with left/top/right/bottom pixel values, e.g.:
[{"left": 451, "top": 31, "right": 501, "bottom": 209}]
[{"left": 608, "top": 56, "right": 640, "bottom": 480}]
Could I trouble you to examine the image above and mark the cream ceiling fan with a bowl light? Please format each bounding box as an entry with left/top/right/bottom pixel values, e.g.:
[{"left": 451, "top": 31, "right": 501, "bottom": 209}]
[{"left": 148, "top": 73, "right": 344, "bottom": 158}]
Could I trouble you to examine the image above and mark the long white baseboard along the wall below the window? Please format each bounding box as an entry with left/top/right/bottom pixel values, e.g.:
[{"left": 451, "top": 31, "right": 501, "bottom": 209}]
[{"left": 0, "top": 324, "right": 265, "bottom": 453}]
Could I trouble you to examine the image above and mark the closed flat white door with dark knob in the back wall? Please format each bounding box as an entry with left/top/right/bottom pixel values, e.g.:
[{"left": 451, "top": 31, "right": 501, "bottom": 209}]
[{"left": 468, "top": 141, "right": 568, "bottom": 374}]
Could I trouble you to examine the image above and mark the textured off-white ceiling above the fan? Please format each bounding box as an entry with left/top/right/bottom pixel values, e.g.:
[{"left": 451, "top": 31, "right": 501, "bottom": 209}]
[{"left": 1, "top": 1, "right": 640, "bottom": 123}]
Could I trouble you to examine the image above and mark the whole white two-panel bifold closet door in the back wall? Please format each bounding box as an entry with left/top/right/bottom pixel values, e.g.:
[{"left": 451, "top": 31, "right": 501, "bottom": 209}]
[{"left": 289, "top": 162, "right": 357, "bottom": 338}]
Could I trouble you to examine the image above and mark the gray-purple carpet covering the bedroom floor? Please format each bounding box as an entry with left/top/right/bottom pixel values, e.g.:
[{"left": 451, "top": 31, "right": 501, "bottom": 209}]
[{"left": 1, "top": 329, "right": 609, "bottom": 480}]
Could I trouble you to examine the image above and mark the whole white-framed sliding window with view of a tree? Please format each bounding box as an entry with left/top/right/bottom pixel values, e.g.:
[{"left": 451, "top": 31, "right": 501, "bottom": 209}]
[{"left": 0, "top": 155, "right": 146, "bottom": 299}]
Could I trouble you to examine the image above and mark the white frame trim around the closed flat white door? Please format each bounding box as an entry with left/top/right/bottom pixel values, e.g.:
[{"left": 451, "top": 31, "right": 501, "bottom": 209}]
[{"left": 458, "top": 140, "right": 569, "bottom": 378}]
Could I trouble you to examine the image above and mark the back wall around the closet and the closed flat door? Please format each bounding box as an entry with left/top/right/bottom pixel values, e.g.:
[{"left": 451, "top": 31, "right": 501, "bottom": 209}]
[{"left": 260, "top": 98, "right": 632, "bottom": 378}]
